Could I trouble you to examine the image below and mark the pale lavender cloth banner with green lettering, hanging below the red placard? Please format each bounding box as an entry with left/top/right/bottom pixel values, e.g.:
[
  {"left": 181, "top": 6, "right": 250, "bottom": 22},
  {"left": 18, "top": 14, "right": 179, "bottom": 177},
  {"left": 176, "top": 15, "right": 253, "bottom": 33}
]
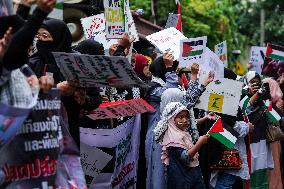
[{"left": 80, "top": 115, "right": 141, "bottom": 189}]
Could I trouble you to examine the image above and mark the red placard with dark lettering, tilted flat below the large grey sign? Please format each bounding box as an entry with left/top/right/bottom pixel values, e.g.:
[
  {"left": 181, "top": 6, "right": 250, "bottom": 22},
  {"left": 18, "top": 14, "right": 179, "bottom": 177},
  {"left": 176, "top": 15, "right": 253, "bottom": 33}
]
[{"left": 88, "top": 98, "right": 155, "bottom": 120}]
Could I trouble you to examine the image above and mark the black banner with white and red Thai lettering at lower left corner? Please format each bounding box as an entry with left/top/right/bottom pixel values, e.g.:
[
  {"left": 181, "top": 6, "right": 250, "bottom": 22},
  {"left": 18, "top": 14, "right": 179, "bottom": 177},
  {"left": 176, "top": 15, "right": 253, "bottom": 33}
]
[{"left": 0, "top": 89, "right": 86, "bottom": 189}]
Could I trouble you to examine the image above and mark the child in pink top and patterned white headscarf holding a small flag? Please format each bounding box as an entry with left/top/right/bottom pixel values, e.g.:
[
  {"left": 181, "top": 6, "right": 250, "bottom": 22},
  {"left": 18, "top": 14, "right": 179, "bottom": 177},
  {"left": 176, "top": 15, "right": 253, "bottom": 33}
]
[{"left": 154, "top": 102, "right": 209, "bottom": 189}]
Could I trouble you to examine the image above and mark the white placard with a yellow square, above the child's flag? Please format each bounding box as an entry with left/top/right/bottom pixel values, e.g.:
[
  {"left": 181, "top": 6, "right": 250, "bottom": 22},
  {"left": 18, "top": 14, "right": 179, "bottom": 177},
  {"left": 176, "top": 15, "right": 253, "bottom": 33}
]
[{"left": 195, "top": 79, "right": 243, "bottom": 116}]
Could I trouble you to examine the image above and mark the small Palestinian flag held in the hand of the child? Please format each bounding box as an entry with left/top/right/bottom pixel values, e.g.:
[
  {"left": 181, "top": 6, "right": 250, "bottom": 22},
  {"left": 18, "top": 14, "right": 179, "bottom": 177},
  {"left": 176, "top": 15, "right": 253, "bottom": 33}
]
[{"left": 208, "top": 117, "right": 237, "bottom": 149}]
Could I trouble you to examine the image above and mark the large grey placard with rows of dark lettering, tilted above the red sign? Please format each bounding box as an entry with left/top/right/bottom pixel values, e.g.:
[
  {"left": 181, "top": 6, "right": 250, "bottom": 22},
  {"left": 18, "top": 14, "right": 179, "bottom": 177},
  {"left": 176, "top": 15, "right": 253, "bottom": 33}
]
[{"left": 53, "top": 52, "right": 147, "bottom": 87}]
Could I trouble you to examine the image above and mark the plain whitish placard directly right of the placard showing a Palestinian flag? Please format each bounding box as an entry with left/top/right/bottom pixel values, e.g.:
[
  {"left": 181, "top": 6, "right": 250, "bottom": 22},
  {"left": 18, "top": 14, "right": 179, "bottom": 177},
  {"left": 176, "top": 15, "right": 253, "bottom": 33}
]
[{"left": 199, "top": 48, "right": 224, "bottom": 83}]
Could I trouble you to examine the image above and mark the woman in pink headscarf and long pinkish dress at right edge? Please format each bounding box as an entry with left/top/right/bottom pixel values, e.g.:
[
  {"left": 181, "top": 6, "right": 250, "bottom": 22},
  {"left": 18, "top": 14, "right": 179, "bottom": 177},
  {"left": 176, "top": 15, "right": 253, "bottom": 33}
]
[{"left": 263, "top": 78, "right": 283, "bottom": 189}]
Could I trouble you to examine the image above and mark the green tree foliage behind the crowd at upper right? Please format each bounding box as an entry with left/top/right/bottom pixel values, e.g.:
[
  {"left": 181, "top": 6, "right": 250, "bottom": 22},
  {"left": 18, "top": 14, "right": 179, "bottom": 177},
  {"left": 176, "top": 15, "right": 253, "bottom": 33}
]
[{"left": 130, "top": 0, "right": 284, "bottom": 69}]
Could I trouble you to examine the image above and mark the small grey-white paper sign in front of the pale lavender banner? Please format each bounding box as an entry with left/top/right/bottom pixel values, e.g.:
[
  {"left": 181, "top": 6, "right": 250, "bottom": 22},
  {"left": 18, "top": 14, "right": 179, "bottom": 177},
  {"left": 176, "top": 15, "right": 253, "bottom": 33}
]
[{"left": 80, "top": 143, "right": 112, "bottom": 179}]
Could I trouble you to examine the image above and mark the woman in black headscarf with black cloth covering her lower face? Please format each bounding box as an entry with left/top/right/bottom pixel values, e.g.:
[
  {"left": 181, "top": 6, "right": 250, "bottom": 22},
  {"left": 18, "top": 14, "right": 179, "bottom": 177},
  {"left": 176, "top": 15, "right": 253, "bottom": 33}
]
[{"left": 29, "top": 19, "right": 72, "bottom": 84}]
